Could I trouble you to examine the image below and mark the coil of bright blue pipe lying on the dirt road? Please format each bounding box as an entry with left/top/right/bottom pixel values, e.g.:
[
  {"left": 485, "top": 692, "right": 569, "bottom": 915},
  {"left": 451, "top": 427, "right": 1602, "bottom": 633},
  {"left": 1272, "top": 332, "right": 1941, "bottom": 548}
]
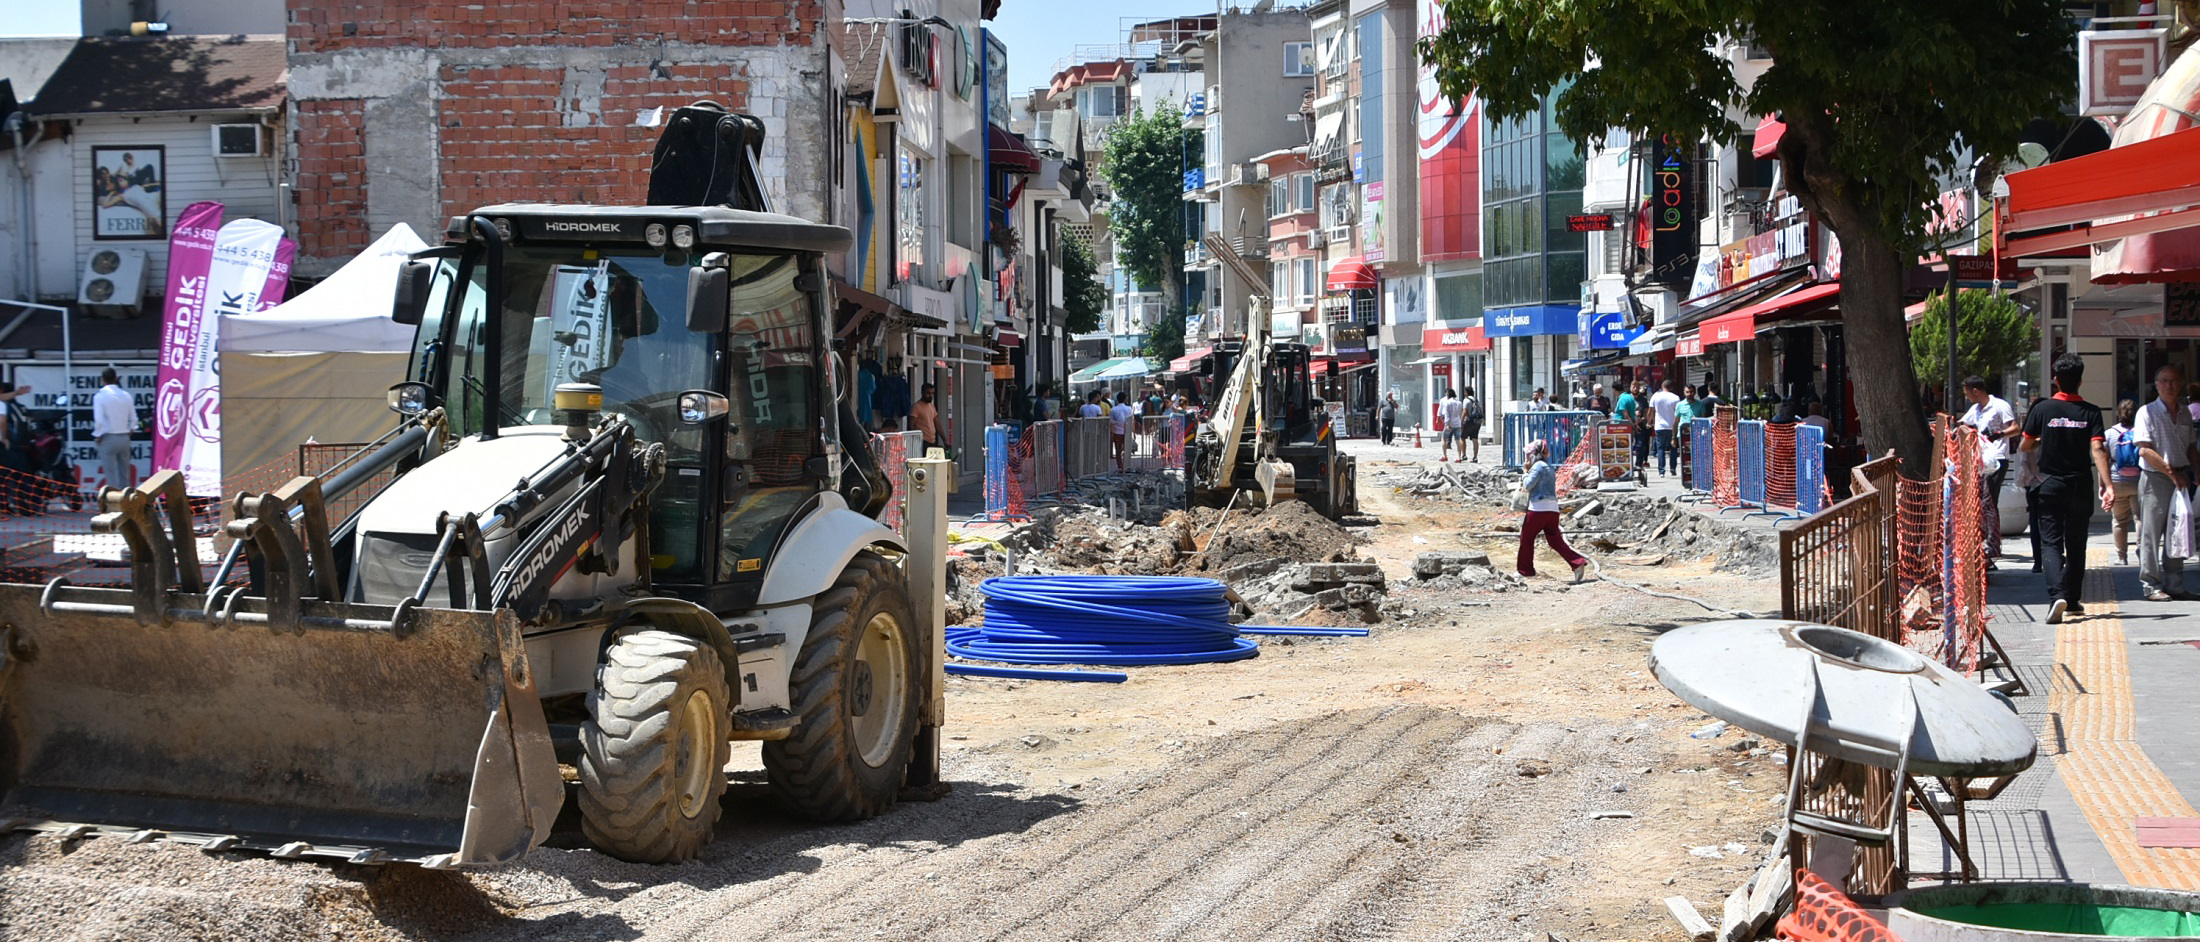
[{"left": 948, "top": 574, "right": 1261, "bottom": 667}]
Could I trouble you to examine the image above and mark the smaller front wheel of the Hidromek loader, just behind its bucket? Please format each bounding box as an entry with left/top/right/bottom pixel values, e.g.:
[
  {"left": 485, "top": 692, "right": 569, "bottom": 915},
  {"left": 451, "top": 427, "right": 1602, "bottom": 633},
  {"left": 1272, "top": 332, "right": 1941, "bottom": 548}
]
[{"left": 579, "top": 629, "right": 733, "bottom": 863}]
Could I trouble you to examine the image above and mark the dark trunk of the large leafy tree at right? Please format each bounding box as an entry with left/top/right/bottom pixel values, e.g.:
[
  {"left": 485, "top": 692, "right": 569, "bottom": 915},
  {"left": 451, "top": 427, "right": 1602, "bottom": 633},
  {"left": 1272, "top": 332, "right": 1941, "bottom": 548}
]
[{"left": 1839, "top": 227, "right": 1936, "bottom": 480}]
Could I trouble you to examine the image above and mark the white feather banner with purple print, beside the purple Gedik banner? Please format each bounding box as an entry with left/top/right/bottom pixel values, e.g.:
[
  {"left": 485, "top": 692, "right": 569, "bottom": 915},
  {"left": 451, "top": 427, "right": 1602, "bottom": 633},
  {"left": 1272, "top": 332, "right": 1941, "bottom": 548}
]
[{"left": 177, "top": 220, "right": 288, "bottom": 497}]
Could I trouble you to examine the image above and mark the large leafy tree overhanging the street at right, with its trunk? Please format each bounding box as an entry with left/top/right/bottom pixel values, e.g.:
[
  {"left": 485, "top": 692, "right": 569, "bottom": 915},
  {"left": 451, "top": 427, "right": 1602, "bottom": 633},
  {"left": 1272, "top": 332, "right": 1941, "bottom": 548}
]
[{"left": 1421, "top": 0, "right": 2072, "bottom": 473}]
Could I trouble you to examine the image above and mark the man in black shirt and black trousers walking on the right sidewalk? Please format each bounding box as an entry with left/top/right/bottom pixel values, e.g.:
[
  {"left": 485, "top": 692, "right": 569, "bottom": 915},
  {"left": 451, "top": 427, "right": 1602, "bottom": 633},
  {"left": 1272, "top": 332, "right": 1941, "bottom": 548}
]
[{"left": 2024, "top": 354, "right": 2116, "bottom": 625}]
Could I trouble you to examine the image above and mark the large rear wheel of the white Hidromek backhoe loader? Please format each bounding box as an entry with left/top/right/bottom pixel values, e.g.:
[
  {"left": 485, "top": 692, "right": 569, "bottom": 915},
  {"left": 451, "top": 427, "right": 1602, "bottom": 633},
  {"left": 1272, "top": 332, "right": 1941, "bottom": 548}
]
[{"left": 763, "top": 552, "right": 917, "bottom": 821}]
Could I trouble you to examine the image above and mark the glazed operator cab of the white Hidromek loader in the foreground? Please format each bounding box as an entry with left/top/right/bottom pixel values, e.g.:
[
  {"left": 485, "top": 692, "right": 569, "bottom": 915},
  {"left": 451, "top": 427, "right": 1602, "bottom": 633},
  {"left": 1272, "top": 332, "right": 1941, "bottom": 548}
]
[{"left": 400, "top": 205, "right": 849, "bottom": 612}]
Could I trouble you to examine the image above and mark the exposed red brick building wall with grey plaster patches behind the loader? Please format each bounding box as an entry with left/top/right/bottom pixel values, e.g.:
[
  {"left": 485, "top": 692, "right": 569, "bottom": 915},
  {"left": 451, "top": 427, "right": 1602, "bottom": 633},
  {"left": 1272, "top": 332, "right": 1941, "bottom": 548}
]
[{"left": 288, "top": 0, "right": 843, "bottom": 275}]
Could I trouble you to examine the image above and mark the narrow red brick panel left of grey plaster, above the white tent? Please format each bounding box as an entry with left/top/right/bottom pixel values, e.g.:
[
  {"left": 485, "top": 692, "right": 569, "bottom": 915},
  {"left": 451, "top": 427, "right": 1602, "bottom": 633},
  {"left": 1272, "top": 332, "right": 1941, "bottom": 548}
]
[{"left": 295, "top": 99, "right": 370, "bottom": 255}]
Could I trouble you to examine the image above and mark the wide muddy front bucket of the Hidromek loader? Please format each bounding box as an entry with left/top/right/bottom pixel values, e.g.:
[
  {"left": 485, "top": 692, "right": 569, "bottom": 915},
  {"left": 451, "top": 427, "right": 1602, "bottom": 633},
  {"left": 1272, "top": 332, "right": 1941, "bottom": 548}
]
[{"left": 0, "top": 585, "right": 563, "bottom": 867}]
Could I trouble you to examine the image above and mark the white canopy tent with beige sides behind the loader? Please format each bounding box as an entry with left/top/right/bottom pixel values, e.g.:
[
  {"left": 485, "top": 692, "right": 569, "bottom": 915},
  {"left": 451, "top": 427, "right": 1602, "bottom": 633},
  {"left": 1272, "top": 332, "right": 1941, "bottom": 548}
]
[{"left": 218, "top": 222, "right": 427, "bottom": 495}]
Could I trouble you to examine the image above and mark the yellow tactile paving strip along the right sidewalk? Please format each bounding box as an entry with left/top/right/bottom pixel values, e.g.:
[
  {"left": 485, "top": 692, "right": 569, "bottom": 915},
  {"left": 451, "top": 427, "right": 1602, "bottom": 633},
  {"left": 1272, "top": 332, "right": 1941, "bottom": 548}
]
[{"left": 2048, "top": 559, "right": 2200, "bottom": 891}]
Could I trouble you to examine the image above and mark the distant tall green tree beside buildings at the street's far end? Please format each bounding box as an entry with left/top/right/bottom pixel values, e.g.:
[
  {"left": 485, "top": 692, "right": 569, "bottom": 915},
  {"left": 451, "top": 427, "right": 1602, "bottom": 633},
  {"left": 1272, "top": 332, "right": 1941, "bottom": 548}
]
[{"left": 1100, "top": 99, "right": 1199, "bottom": 330}]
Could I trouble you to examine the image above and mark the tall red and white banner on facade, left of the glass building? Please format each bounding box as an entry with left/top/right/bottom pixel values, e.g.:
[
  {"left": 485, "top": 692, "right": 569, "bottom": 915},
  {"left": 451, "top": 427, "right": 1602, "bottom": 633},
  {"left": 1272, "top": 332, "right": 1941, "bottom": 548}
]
[{"left": 1415, "top": 0, "right": 1483, "bottom": 262}]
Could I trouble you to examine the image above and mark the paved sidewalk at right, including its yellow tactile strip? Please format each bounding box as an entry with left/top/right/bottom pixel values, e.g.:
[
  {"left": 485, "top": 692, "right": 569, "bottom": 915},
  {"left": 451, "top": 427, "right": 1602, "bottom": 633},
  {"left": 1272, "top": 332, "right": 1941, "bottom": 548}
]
[{"left": 1912, "top": 515, "right": 2200, "bottom": 889}]
